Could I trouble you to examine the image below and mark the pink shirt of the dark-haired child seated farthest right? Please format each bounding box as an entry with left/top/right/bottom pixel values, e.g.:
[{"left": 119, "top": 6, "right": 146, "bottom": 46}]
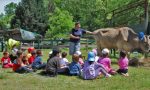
[{"left": 118, "top": 57, "right": 129, "bottom": 69}]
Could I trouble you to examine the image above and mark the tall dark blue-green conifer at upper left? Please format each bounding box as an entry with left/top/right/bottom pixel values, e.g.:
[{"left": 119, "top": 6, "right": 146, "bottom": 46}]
[{"left": 11, "top": 0, "right": 48, "bottom": 35}]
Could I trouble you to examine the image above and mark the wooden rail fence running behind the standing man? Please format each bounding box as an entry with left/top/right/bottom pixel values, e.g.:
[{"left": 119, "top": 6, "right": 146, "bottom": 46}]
[{"left": 0, "top": 39, "right": 96, "bottom": 52}]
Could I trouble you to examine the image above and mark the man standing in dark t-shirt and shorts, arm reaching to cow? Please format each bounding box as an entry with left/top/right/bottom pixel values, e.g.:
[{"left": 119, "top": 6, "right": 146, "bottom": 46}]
[{"left": 69, "top": 22, "right": 94, "bottom": 55}]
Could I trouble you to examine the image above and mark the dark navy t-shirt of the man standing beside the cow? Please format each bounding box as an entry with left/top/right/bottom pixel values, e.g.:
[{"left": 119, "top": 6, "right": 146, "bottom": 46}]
[{"left": 70, "top": 28, "right": 86, "bottom": 43}]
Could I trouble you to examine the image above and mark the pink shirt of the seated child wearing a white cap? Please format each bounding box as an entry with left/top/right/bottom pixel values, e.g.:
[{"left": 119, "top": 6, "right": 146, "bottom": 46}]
[{"left": 98, "top": 57, "right": 111, "bottom": 72}]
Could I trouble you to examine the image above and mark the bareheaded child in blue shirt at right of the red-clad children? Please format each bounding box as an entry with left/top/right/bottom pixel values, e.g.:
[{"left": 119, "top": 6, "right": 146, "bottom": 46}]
[{"left": 32, "top": 50, "right": 46, "bottom": 69}]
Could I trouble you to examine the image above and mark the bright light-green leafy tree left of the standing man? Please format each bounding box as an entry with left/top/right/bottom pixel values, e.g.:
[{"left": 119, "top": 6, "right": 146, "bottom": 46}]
[{"left": 45, "top": 8, "right": 74, "bottom": 39}]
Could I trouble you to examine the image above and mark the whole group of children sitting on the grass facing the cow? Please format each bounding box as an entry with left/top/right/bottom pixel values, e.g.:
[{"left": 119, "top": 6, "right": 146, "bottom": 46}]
[{"left": 1, "top": 48, "right": 129, "bottom": 80}]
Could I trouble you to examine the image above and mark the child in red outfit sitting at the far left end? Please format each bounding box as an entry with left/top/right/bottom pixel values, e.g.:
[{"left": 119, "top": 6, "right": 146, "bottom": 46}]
[{"left": 1, "top": 51, "right": 13, "bottom": 68}]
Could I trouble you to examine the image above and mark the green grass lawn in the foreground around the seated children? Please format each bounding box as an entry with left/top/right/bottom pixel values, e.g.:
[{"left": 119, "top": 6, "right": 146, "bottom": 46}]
[{"left": 0, "top": 49, "right": 150, "bottom": 90}]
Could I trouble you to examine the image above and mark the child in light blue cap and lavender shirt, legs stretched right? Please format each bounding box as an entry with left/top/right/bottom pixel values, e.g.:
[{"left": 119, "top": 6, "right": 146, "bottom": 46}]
[{"left": 83, "top": 52, "right": 111, "bottom": 80}]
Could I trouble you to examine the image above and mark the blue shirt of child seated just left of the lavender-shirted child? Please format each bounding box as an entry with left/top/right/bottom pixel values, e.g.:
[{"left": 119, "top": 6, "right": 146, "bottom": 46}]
[{"left": 69, "top": 62, "right": 81, "bottom": 75}]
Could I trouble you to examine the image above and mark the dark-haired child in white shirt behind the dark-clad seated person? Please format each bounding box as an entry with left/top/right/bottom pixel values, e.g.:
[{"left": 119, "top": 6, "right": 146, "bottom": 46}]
[{"left": 60, "top": 52, "right": 69, "bottom": 68}]
